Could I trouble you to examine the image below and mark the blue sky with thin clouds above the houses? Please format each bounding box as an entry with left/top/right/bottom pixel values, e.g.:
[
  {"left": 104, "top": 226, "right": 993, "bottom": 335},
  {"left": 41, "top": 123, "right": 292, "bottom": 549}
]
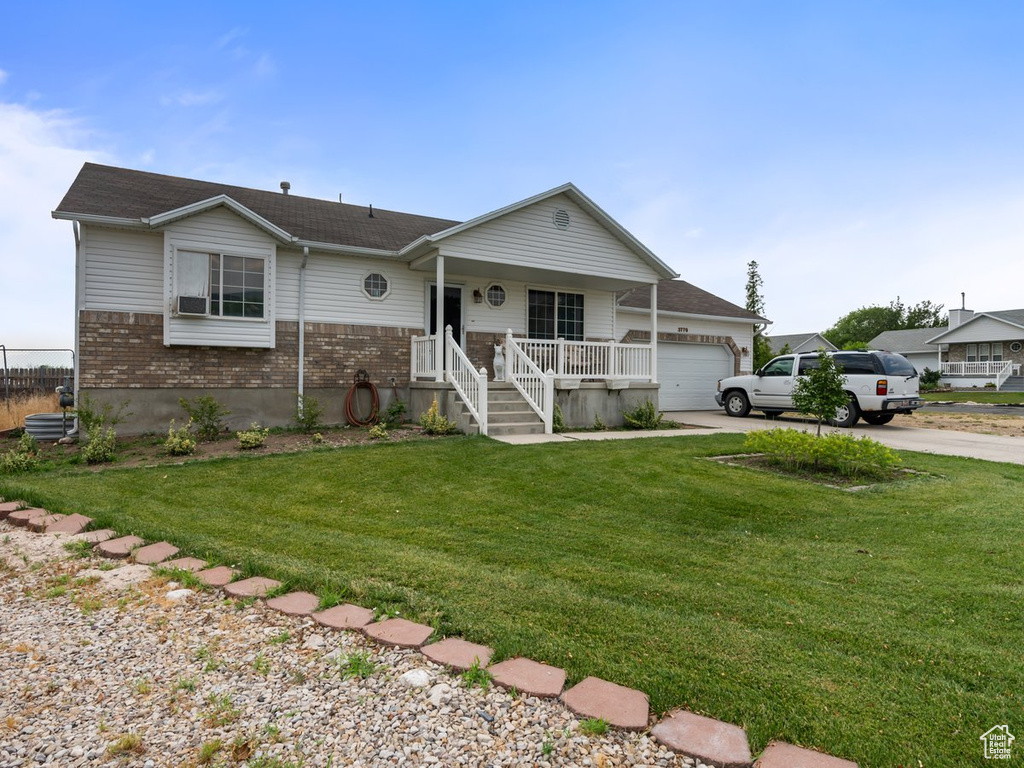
[{"left": 0, "top": 0, "right": 1024, "bottom": 347}]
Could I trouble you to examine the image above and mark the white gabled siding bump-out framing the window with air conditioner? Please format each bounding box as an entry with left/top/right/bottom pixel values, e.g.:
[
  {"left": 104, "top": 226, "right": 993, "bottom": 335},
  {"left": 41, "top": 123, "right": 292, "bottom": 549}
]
[{"left": 164, "top": 208, "right": 276, "bottom": 348}]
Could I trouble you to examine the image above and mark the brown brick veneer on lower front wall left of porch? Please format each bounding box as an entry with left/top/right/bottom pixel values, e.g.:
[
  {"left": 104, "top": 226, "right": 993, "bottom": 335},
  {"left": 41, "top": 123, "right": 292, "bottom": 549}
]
[{"left": 78, "top": 311, "right": 423, "bottom": 389}]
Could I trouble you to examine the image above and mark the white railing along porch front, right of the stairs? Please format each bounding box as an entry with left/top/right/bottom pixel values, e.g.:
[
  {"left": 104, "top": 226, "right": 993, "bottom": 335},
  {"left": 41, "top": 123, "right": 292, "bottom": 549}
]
[{"left": 515, "top": 339, "right": 651, "bottom": 381}]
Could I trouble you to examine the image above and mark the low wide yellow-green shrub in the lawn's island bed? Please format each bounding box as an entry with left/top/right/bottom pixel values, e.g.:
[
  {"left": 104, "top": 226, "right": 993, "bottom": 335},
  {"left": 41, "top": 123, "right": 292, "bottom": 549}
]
[{"left": 744, "top": 429, "right": 902, "bottom": 479}]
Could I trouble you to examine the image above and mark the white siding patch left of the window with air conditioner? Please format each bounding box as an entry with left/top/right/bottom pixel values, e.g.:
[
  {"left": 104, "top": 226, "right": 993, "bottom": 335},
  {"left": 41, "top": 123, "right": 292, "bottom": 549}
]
[{"left": 81, "top": 226, "right": 164, "bottom": 314}]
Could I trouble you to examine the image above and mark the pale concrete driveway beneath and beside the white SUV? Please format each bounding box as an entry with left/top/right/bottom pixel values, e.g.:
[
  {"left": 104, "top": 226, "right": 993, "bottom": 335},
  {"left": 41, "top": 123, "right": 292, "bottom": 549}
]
[{"left": 666, "top": 411, "right": 1024, "bottom": 464}]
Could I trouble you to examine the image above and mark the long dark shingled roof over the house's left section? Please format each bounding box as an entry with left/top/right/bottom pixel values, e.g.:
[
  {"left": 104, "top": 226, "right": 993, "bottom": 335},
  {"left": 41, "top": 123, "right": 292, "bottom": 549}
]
[{"left": 55, "top": 163, "right": 461, "bottom": 251}]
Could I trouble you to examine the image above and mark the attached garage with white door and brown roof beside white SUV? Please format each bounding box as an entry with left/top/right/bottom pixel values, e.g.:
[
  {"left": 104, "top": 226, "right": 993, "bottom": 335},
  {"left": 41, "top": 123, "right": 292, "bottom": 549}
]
[{"left": 615, "top": 280, "right": 768, "bottom": 411}]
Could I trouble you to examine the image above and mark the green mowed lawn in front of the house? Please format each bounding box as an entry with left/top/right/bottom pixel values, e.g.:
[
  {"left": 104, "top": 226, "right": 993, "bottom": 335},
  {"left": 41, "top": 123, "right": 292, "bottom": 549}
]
[{"left": 0, "top": 435, "right": 1024, "bottom": 768}]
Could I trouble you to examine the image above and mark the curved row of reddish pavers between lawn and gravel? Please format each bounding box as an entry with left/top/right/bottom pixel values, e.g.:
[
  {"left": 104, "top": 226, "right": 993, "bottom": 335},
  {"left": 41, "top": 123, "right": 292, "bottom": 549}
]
[{"left": 0, "top": 500, "right": 857, "bottom": 768}]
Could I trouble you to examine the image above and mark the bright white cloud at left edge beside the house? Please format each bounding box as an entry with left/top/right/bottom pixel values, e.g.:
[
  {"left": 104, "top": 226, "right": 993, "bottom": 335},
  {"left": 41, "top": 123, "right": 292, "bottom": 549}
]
[{"left": 0, "top": 102, "right": 103, "bottom": 347}]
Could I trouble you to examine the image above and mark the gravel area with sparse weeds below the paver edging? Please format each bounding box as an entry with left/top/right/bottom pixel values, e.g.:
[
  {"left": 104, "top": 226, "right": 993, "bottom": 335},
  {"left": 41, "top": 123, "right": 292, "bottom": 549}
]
[{"left": 0, "top": 522, "right": 702, "bottom": 768}]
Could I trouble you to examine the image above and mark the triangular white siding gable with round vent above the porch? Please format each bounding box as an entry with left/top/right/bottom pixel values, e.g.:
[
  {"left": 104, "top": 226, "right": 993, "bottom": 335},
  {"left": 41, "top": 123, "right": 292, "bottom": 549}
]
[{"left": 440, "top": 195, "right": 659, "bottom": 283}]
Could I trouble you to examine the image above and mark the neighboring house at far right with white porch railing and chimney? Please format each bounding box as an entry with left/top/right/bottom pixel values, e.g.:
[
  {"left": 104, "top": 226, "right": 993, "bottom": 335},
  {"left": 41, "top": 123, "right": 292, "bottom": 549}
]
[{"left": 928, "top": 309, "right": 1024, "bottom": 389}]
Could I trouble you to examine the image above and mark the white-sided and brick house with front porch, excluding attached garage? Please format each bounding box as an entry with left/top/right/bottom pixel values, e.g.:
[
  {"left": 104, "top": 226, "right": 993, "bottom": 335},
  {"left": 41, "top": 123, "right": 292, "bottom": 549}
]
[{"left": 53, "top": 163, "right": 679, "bottom": 433}]
